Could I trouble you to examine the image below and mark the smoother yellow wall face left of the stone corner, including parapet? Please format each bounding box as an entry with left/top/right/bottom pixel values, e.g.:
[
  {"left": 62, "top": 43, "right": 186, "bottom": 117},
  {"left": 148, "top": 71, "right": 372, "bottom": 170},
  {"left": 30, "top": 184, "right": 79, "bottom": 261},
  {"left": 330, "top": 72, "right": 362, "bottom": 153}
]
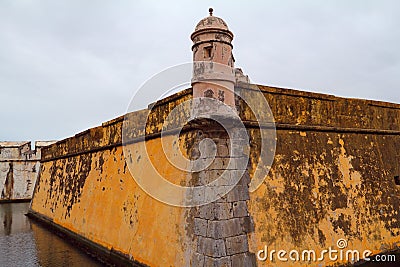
[{"left": 31, "top": 90, "right": 193, "bottom": 266}]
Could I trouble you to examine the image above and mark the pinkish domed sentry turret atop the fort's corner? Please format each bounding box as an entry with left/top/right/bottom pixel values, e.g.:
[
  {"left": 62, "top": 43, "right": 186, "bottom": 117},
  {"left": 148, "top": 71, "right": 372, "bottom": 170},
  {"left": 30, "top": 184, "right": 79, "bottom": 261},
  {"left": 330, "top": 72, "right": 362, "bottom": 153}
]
[{"left": 191, "top": 8, "right": 235, "bottom": 107}]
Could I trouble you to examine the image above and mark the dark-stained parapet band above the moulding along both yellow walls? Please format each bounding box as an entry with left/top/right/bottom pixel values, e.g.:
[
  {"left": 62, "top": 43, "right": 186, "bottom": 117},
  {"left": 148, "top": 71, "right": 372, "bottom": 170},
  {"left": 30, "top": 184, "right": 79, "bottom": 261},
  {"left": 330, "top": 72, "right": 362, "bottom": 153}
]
[{"left": 38, "top": 84, "right": 400, "bottom": 161}]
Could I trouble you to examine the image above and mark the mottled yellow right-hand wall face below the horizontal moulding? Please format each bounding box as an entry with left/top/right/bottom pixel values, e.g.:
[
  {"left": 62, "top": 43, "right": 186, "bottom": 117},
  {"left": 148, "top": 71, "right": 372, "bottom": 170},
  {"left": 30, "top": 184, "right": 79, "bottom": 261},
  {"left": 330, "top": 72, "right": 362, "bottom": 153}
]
[{"left": 249, "top": 130, "right": 400, "bottom": 266}]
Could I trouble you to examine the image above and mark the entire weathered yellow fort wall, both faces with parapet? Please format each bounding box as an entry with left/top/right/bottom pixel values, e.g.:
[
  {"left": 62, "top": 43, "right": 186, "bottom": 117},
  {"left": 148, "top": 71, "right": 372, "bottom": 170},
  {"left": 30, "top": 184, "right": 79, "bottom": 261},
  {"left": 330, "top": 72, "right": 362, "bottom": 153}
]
[{"left": 30, "top": 86, "right": 400, "bottom": 266}]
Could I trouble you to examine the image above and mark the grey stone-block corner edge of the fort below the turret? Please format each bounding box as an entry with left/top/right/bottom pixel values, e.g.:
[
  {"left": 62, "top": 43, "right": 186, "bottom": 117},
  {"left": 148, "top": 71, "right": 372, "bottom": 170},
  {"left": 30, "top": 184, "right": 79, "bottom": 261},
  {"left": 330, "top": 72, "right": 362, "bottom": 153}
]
[{"left": 189, "top": 121, "right": 256, "bottom": 267}]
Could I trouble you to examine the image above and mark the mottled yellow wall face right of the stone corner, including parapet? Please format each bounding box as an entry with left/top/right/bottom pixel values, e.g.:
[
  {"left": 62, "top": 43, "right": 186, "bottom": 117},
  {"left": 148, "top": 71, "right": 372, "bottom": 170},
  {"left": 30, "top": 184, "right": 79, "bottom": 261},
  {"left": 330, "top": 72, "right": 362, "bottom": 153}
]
[{"left": 242, "top": 86, "right": 400, "bottom": 266}]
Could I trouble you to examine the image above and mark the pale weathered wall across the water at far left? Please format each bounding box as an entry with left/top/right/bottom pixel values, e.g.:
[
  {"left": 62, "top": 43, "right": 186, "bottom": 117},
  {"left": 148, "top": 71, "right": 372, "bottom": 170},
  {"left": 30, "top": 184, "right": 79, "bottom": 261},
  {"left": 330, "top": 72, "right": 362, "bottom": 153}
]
[{"left": 0, "top": 141, "right": 55, "bottom": 201}]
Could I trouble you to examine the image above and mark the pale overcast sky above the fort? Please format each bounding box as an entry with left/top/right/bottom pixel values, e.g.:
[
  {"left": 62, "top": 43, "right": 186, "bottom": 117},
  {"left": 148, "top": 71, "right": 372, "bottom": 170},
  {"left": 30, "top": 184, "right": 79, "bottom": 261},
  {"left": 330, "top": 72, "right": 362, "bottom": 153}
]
[{"left": 0, "top": 0, "right": 400, "bottom": 140}]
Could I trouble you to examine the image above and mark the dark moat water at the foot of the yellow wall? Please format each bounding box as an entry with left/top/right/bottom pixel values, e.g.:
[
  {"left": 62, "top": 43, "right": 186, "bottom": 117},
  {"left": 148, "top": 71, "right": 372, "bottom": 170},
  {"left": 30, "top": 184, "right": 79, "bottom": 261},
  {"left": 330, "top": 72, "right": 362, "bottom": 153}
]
[{"left": 0, "top": 203, "right": 103, "bottom": 267}]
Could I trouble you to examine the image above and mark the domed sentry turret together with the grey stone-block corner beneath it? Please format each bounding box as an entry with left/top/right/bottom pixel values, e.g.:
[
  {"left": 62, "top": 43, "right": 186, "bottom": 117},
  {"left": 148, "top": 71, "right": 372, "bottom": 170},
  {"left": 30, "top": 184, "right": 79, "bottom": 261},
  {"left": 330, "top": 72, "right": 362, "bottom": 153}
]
[{"left": 189, "top": 8, "right": 256, "bottom": 266}]
